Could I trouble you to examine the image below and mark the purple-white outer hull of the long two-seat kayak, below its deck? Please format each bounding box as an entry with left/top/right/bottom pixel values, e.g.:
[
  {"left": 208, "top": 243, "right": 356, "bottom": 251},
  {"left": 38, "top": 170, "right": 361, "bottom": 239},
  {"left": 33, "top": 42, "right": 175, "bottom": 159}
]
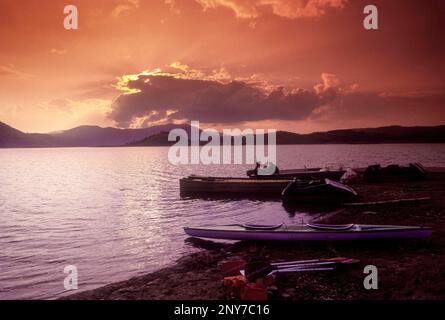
[{"left": 184, "top": 227, "right": 432, "bottom": 241}]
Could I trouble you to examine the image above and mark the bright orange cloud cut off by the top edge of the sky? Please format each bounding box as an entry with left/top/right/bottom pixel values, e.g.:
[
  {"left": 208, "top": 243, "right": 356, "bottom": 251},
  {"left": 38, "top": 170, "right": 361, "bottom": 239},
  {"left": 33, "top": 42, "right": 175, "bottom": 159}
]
[{"left": 196, "top": 0, "right": 347, "bottom": 19}]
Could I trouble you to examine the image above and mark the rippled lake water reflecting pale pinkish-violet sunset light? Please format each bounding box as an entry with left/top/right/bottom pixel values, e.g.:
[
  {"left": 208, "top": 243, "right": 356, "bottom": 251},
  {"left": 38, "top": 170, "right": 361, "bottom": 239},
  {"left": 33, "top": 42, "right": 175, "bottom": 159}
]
[{"left": 0, "top": 144, "right": 445, "bottom": 299}]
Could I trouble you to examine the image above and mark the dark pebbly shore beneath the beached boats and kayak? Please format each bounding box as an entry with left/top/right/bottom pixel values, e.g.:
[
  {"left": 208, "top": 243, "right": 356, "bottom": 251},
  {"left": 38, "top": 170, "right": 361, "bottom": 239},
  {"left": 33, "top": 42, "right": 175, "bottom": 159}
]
[{"left": 60, "top": 172, "right": 445, "bottom": 300}]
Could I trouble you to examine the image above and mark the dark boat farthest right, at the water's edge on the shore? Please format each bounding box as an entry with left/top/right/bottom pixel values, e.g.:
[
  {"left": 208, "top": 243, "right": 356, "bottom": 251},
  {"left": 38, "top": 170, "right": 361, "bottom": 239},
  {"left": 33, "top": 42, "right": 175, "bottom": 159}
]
[{"left": 363, "top": 162, "right": 427, "bottom": 182}]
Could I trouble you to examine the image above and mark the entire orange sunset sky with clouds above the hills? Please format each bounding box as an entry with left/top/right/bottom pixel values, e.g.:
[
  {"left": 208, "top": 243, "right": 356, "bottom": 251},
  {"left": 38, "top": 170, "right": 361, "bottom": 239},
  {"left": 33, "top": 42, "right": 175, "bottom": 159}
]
[{"left": 0, "top": 0, "right": 445, "bottom": 132}]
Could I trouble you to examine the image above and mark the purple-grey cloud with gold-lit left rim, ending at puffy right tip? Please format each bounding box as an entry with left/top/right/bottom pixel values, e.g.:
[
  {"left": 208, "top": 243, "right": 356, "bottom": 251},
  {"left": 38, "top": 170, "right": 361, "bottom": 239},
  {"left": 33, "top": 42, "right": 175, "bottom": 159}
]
[{"left": 109, "top": 68, "right": 341, "bottom": 127}]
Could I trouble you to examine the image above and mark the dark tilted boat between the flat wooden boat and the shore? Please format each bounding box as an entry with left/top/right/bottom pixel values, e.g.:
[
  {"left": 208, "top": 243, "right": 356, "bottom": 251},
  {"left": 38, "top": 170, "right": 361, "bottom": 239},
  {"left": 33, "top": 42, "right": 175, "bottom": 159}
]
[{"left": 282, "top": 179, "right": 357, "bottom": 202}]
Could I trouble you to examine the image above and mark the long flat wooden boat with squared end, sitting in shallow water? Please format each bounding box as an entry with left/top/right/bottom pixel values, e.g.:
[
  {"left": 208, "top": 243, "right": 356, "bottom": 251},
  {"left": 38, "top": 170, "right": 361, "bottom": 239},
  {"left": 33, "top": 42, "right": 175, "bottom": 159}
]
[{"left": 179, "top": 176, "right": 292, "bottom": 196}]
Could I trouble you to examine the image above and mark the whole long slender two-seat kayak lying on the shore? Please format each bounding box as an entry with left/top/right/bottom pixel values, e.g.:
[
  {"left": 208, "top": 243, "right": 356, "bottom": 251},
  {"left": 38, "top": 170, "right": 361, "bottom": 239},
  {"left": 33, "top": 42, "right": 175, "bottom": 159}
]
[{"left": 184, "top": 223, "right": 432, "bottom": 241}]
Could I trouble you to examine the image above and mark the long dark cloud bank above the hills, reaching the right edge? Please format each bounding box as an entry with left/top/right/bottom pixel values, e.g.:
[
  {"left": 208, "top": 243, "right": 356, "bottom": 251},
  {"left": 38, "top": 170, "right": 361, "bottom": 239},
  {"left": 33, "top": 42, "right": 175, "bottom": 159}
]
[{"left": 109, "top": 75, "right": 445, "bottom": 127}]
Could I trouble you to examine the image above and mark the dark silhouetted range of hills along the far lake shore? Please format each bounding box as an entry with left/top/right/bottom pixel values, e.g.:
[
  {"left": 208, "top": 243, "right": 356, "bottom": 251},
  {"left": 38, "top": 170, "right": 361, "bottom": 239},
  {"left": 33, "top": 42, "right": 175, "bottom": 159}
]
[{"left": 0, "top": 122, "right": 445, "bottom": 148}]
